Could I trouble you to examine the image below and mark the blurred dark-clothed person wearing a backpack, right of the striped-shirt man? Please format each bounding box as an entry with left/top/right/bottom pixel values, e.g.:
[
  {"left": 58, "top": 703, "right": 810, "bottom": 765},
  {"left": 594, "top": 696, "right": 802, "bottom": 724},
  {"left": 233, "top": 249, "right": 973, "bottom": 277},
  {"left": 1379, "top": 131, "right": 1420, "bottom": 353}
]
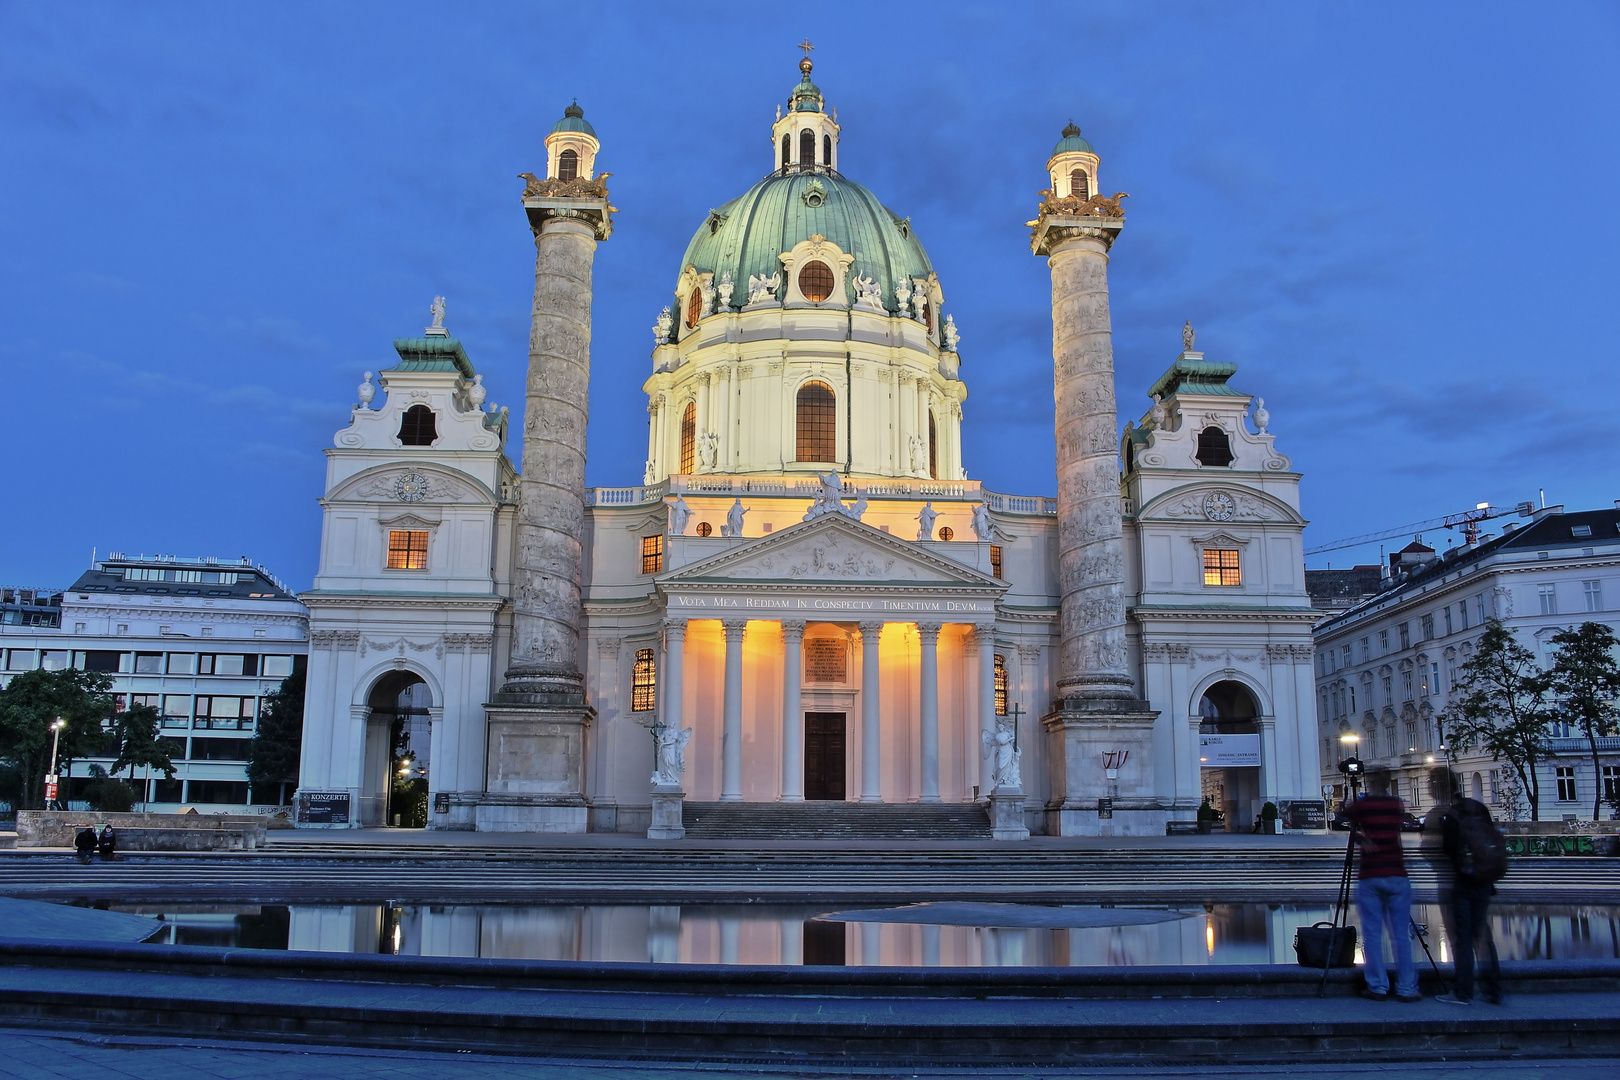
[{"left": 1424, "top": 769, "right": 1508, "bottom": 1006}]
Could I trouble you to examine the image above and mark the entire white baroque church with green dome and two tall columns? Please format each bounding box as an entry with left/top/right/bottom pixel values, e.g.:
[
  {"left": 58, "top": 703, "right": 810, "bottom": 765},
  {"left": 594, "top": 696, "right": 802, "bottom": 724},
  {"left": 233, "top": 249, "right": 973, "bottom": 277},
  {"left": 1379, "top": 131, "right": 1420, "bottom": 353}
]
[{"left": 300, "top": 60, "right": 1319, "bottom": 837}]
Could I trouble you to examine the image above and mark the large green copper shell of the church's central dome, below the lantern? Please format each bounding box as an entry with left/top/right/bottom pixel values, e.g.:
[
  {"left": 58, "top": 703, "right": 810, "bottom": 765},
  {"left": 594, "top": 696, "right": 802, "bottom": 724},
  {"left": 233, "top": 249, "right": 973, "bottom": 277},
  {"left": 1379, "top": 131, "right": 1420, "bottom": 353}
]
[{"left": 680, "top": 172, "right": 933, "bottom": 311}]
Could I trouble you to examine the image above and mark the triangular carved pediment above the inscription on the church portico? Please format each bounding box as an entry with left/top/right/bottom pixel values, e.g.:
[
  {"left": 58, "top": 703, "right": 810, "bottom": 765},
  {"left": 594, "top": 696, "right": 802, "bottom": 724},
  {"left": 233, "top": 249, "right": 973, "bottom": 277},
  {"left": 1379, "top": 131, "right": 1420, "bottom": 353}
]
[{"left": 658, "top": 513, "right": 1008, "bottom": 593}]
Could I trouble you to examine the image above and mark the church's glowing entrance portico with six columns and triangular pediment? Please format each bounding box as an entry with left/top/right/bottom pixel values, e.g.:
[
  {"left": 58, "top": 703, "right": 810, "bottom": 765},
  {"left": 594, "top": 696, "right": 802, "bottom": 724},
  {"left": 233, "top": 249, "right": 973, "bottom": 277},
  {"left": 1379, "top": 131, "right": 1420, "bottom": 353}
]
[{"left": 641, "top": 515, "right": 1006, "bottom": 803}]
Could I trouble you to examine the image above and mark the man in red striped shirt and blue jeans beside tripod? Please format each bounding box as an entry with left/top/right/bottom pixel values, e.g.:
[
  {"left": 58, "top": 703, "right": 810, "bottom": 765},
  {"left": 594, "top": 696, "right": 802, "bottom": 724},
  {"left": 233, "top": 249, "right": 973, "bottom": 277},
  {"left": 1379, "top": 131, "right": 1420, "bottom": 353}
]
[{"left": 1345, "top": 795, "right": 1422, "bottom": 1001}]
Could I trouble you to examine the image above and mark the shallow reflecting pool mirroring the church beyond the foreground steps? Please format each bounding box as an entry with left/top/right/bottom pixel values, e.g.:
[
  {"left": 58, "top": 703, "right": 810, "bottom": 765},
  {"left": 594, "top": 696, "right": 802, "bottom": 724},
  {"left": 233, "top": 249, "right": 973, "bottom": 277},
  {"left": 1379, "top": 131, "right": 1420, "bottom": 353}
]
[{"left": 91, "top": 904, "right": 1620, "bottom": 967}]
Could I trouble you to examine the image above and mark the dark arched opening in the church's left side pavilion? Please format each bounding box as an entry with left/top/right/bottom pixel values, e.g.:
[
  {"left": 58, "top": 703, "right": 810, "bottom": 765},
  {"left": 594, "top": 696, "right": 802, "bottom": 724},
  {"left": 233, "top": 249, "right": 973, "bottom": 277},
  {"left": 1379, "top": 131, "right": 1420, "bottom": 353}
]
[{"left": 365, "top": 670, "right": 433, "bottom": 829}]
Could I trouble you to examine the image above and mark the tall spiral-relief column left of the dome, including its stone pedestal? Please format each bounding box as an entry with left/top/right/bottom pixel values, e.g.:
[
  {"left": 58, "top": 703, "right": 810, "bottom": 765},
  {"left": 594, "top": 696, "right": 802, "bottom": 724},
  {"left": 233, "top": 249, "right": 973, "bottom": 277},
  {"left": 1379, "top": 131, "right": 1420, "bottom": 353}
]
[{"left": 478, "top": 105, "right": 614, "bottom": 832}]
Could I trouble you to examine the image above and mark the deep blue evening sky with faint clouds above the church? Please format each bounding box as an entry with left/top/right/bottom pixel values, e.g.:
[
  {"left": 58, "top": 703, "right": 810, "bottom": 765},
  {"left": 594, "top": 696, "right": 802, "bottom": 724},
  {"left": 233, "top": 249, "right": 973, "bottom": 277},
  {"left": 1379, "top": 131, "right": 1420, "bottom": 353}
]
[{"left": 0, "top": 0, "right": 1620, "bottom": 588}]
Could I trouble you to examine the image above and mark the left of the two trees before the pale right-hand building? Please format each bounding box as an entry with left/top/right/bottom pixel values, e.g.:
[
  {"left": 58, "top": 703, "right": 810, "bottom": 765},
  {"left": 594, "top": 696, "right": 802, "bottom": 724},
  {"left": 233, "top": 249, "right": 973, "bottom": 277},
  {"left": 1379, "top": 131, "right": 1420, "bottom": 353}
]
[{"left": 1445, "top": 619, "right": 1554, "bottom": 821}]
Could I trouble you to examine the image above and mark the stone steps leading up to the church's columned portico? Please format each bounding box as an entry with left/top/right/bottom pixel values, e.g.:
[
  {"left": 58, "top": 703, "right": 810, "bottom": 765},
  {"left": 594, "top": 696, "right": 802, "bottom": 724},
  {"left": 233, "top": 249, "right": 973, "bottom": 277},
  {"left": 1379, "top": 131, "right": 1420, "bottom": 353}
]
[{"left": 680, "top": 801, "right": 990, "bottom": 840}]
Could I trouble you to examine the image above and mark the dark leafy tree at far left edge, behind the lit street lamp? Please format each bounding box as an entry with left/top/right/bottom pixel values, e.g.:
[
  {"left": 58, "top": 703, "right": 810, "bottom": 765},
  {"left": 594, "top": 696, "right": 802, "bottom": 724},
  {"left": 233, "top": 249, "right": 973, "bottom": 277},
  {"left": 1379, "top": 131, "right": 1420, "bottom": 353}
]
[{"left": 0, "top": 669, "right": 113, "bottom": 810}]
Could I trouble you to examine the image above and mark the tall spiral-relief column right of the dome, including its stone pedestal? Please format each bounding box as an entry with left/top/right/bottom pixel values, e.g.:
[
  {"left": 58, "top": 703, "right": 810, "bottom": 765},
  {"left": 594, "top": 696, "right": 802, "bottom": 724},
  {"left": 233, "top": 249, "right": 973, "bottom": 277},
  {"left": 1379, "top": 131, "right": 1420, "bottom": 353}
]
[{"left": 1030, "top": 123, "right": 1166, "bottom": 834}]
